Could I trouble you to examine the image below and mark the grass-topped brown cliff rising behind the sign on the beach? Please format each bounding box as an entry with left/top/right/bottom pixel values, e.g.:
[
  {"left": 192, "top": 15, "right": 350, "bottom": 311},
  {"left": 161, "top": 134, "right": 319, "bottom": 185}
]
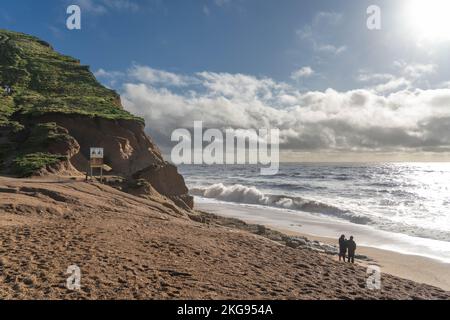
[{"left": 0, "top": 30, "right": 193, "bottom": 208}]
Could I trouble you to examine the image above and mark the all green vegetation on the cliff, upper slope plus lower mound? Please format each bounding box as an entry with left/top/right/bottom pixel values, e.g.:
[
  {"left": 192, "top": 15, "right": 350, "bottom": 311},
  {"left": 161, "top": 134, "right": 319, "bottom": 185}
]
[{"left": 0, "top": 29, "right": 143, "bottom": 176}]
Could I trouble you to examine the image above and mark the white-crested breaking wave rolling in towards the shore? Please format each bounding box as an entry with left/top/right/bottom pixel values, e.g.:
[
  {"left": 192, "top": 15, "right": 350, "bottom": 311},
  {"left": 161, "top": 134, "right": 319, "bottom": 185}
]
[{"left": 190, "top": 183, "right": 373, "bottom": 224}]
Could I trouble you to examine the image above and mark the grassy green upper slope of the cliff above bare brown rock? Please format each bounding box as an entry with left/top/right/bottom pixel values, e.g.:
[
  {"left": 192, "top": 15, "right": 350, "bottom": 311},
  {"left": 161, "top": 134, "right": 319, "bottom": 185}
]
[{"left": 0, "top": 30, "right": 143, "bottom": 126}]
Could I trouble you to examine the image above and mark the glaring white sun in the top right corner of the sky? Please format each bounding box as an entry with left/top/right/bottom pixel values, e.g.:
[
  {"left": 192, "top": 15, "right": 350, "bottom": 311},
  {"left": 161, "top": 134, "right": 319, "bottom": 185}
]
[{"left": 406, "top": 0, "right": 450, "bottom": 41}]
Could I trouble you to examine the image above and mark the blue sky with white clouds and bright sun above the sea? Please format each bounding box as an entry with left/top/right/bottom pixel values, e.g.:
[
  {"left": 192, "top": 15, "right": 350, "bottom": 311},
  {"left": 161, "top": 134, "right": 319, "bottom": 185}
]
[{"left": 0, "top": 0, "right": 450, "bottom": 162}]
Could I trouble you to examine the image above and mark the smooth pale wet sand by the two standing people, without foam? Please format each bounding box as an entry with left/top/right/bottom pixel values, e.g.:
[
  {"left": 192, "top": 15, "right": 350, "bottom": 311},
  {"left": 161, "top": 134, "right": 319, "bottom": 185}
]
[{"left": 196, "top": 201, "right": 450, "bottom": 291}]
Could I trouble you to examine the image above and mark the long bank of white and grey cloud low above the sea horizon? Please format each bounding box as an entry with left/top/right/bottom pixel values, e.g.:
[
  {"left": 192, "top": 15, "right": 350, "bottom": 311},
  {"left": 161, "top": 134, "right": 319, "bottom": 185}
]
[{"left": 107, "top": 68, "right": 450, "bottom": 152}]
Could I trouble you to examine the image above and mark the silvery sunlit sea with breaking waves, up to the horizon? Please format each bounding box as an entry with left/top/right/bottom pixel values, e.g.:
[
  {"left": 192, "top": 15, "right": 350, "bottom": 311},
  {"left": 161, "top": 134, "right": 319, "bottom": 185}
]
[{"left": 179, "top": 163, "right": 450, "bottom": 260}]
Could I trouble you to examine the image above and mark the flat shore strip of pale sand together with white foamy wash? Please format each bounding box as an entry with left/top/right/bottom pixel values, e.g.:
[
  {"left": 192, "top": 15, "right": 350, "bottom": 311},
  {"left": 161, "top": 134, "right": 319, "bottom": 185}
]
[{"left": 197, "top": 201, "right": 450, "bottom": 290}]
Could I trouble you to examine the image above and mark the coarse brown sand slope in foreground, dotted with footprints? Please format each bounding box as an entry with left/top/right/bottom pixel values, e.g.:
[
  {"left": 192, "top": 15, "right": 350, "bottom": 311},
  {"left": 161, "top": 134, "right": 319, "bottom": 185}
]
[{"left": 0, "top": 178, "right": 450, "bottom": 299}]
